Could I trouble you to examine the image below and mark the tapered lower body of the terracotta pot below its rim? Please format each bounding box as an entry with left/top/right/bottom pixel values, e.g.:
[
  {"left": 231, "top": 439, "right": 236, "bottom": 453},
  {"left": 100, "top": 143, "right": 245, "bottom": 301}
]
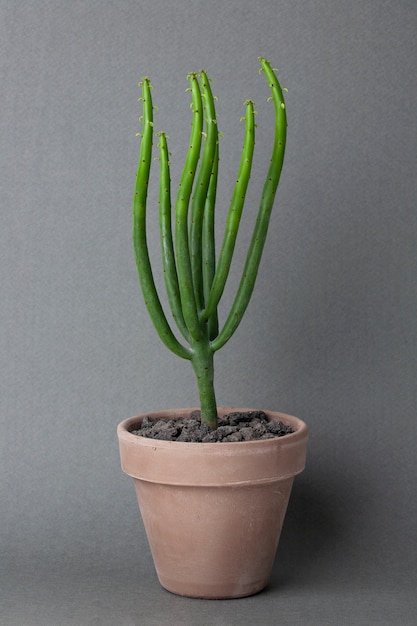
[{"left": 134, "top": 472, "right": 293, "bottom": 599}]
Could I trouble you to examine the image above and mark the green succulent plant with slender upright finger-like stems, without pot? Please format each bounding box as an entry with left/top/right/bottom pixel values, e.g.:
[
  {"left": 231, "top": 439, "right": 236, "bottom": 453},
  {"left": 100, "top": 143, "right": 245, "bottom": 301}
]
[{"left": 133, "top": 57, "right": 287, "bottom": 428}]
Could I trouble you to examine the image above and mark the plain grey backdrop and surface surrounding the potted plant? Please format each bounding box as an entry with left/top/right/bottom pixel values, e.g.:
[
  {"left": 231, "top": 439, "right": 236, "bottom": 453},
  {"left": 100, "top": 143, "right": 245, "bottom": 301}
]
[{"left": 0, "top": 0, "right": 417, "bottom": 626}]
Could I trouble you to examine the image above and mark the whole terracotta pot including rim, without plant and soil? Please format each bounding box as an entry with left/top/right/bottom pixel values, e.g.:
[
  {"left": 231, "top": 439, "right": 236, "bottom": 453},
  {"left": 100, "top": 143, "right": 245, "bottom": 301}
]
[{"left": 118, "top": 407, "right": 308, "bottom": 599}]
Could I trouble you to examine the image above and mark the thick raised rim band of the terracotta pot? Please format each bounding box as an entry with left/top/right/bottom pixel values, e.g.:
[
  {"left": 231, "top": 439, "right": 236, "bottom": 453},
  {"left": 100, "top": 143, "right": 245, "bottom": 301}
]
[{"left": 117, "top": 407, "right": 308, "bottom": 486}]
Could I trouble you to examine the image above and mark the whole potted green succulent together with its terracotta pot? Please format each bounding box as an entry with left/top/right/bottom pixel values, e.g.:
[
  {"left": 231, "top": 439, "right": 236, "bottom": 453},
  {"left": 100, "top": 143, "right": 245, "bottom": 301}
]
[{"left": 118, "top": 58, "right": 308, "bottom": 598}]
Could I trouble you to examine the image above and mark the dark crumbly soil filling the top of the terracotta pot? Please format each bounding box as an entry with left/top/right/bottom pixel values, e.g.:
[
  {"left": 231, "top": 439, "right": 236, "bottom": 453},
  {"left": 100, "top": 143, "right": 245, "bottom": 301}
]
[{"left": 132, "top": 411, "right": 294, "bottom": 443}]
